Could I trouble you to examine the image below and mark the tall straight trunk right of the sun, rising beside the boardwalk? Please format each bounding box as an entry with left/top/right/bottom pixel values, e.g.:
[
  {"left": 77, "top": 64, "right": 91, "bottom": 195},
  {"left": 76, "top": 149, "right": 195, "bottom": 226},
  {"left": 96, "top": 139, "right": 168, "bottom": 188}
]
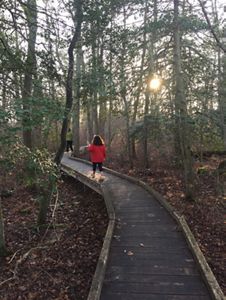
[{"left": 174, "top": 0, "right": 194, "bottom": 200}]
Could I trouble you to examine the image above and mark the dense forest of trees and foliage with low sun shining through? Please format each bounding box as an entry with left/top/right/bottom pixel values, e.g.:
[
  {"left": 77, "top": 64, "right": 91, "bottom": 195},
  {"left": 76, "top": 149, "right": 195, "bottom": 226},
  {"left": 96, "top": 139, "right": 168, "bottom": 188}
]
[{"left": 0, "top": 0, "right": 226, "bottom": 298}]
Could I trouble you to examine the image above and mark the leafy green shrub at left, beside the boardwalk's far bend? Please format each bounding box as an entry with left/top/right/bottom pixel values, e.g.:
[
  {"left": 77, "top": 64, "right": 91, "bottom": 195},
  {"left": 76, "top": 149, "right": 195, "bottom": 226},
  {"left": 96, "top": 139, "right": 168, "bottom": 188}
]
[{"left": 9, "top": 142, "right": 59, "bottom": 226}]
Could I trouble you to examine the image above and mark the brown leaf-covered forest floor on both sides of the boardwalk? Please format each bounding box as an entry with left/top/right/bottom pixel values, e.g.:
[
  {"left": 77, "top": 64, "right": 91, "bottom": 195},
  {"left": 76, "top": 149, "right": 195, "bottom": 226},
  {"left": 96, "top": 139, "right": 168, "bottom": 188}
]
[{"left": 0, "top": 158, "right": 226, "bottom": 300}]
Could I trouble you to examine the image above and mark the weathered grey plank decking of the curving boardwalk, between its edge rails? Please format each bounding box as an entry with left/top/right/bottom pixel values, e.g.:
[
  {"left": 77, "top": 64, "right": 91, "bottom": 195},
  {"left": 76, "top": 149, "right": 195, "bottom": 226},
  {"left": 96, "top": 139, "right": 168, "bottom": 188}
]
[{"left": 62, "top": 156, "right": 216, "bottom": 300}]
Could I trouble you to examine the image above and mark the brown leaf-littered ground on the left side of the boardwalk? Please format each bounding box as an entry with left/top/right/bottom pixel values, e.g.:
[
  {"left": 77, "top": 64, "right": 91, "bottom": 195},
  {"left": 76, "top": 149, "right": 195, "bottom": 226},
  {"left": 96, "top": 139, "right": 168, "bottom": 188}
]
[{"left": 0, "top": 177, "right": 108, "bottom": 300}]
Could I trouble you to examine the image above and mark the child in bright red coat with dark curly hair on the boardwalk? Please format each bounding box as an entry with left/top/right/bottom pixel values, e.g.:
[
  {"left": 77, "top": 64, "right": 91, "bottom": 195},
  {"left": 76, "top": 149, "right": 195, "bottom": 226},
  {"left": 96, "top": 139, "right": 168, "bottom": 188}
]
[{"left": 88, "top": 135, "right": 106, "bottom": 179}]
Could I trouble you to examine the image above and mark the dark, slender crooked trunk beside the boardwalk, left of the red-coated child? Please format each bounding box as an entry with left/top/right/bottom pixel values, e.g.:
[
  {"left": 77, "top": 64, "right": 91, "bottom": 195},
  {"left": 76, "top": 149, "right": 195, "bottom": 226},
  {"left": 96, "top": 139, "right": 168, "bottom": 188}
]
[{"left": 54, "top": 0, "right": 83, "bottom": 164}]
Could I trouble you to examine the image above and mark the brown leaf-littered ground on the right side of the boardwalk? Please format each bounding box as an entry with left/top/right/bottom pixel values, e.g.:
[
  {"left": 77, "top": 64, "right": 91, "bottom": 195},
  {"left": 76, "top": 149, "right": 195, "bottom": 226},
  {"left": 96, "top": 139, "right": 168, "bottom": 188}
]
[{"left": 107, "top": 155, "right": 226, "bottom": 295}]
